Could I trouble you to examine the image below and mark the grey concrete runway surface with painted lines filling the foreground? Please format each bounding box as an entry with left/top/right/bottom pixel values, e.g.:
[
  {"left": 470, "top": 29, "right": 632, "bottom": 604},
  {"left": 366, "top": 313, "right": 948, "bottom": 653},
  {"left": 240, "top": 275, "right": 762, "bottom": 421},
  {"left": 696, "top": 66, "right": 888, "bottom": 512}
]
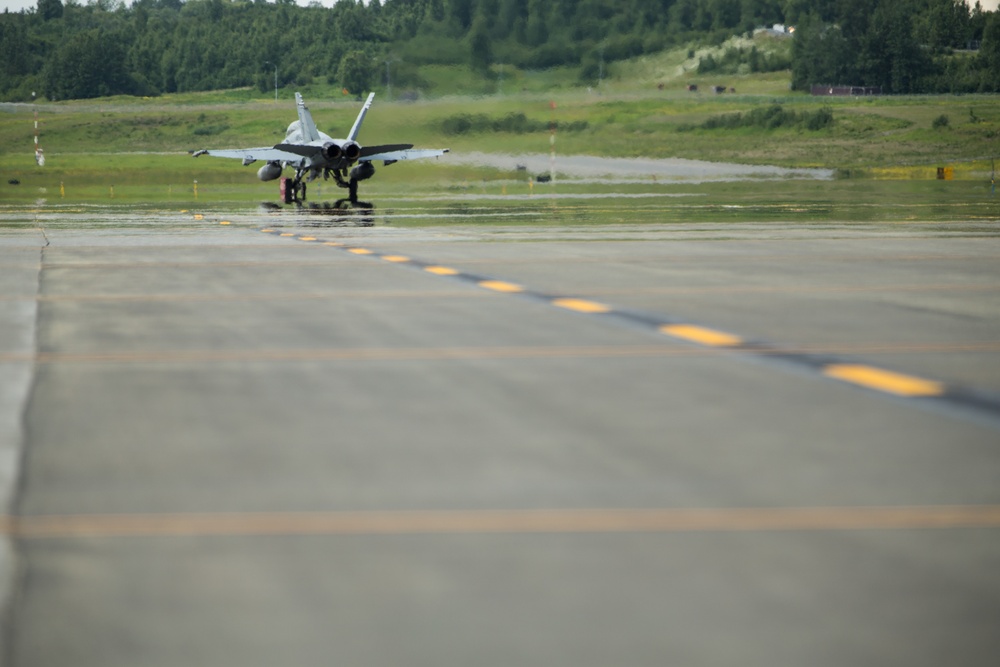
[{"left": 0, "top": 206, "right": 1000, "bottom": 667}]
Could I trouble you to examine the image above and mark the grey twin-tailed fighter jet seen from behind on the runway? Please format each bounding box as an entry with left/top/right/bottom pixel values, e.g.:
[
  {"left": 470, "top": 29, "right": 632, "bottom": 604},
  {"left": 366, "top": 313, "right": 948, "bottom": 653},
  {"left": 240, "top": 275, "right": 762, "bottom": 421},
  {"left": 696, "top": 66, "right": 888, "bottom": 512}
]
[{"left": 193, "top": 93, "right": 448, "bottom": 204}]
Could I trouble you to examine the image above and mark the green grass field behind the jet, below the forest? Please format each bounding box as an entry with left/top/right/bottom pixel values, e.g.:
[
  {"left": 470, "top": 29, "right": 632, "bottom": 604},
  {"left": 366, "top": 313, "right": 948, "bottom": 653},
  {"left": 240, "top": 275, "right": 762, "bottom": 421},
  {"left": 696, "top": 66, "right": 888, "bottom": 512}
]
[{"left": 0, "top": 40, "right": 1000, "bottom": 219}]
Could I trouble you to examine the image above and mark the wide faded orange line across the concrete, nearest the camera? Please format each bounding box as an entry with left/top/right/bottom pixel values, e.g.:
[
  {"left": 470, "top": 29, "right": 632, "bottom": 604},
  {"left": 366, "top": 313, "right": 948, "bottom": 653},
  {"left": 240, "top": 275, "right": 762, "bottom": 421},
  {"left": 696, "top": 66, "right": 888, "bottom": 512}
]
[{"left": 0, "top": 505, "right": 1000, "bottom": 540}]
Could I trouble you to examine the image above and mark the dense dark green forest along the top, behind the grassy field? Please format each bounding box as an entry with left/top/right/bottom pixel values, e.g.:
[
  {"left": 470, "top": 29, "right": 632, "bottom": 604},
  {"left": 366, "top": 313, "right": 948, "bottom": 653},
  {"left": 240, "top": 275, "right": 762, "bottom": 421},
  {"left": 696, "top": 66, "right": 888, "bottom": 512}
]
[{"left": 0, "top": 0, "right": 1000, "bottom": 101}]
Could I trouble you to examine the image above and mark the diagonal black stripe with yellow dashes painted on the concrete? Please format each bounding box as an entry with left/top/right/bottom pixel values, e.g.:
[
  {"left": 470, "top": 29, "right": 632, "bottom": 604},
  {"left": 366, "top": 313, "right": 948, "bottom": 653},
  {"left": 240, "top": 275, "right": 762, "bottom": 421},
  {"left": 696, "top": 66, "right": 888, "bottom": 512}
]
[{"left": 260, "top": 228, "right": 1000, "bottom": 428}]
